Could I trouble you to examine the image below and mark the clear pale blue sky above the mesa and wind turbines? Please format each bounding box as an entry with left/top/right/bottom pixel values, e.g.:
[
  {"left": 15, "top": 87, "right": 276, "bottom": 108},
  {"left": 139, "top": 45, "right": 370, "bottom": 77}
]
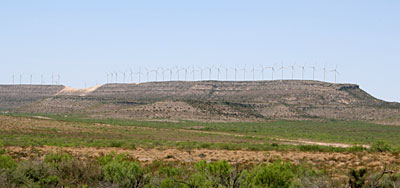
[{"left": 0, "top": 0, "right": 400, "bottom": 102}]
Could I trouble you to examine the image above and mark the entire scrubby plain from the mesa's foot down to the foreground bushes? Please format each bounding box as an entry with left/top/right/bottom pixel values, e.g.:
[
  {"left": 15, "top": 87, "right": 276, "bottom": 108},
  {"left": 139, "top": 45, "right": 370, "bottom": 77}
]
[{"left": 0, "top": 114, "right": 400, "bottom": 187}]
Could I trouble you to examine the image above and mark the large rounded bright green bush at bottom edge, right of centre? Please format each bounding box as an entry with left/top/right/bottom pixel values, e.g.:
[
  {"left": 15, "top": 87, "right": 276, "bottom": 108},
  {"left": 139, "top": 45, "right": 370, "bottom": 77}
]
[{"left": 246, "top": 161, "right": 295, "bottom": 188}]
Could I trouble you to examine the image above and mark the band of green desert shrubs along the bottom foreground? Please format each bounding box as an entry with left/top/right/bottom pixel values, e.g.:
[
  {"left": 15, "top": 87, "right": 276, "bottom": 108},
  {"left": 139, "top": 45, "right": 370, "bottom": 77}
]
[{"left": 0, "top": 153, "right": 400, "bottom": 188}]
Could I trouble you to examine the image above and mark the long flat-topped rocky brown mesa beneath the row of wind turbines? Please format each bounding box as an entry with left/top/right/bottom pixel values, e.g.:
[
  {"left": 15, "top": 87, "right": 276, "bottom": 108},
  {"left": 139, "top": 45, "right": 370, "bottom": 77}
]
[{"left": 0, "top": 80, "right": 400, "bottom": 121}]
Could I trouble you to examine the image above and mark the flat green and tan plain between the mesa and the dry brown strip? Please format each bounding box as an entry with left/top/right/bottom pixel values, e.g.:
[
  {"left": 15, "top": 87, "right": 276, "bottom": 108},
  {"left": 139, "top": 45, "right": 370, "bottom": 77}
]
[{"left": 0, "top": 114, "right": 400, "bottom": 150}]
